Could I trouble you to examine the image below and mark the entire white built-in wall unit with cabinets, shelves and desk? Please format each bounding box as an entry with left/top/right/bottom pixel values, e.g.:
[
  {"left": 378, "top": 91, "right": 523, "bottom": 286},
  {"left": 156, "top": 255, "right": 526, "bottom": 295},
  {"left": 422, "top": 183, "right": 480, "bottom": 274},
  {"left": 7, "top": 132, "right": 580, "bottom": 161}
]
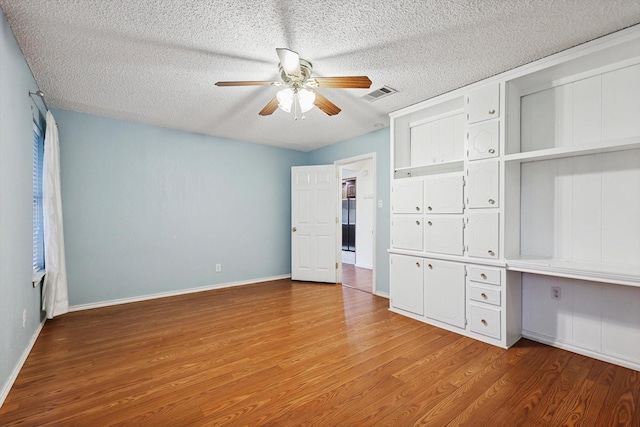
[{"left": 390, "top": 26, "right": 640, "bottom": 370}]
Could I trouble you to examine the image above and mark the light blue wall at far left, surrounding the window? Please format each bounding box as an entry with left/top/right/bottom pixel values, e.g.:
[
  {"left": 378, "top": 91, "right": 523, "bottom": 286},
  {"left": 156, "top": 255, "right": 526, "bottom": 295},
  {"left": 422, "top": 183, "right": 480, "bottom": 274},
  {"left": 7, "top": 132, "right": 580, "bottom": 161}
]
[{"left": 0, "top": 11, "right": 43, "bottom": 401}]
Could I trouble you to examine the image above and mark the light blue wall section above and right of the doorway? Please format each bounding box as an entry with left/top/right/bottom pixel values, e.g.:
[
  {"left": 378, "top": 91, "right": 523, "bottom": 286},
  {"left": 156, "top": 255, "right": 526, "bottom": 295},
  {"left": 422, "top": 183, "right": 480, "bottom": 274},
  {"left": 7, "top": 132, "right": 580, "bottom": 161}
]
[{"left": 309, "top": 128, "right": 390, "bottom": 295}]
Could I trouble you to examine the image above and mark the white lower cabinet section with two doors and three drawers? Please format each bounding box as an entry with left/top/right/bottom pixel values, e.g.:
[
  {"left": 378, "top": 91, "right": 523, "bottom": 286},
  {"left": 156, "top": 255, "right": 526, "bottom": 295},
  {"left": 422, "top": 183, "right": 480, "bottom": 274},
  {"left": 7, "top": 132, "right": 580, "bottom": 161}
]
[{"left": 390, "top": 253, "right": 522, "bottom": 348}]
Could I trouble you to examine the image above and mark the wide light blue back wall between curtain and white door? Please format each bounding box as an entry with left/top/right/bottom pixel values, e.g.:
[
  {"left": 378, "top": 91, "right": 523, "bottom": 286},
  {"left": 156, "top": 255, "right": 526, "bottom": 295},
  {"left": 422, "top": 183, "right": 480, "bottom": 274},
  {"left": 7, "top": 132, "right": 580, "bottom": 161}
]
[{"left": 53, "top": 109, "right": 307, "bottom": 306}]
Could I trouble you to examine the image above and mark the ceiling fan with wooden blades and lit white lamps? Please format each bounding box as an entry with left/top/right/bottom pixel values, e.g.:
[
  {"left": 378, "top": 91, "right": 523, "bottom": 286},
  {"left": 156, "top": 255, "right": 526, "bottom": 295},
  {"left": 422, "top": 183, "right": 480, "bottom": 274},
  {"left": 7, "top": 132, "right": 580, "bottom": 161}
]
[{"left": 216, "top": 48, "right": 371, "bottom": 120}]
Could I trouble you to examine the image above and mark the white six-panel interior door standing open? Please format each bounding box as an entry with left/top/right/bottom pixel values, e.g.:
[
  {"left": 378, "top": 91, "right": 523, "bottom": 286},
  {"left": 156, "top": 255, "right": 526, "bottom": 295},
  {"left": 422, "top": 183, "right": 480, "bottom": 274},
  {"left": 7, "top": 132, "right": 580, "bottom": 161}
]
[{"left": 291, "top": 165, "right": 338, "bottom": 283}]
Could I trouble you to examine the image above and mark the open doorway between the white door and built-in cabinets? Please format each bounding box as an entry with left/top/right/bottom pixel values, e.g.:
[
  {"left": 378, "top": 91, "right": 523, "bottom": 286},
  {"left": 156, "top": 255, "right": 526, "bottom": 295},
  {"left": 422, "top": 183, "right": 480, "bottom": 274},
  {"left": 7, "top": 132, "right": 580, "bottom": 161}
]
[{"left": 336, "top": 153, "right": 376, "bottom": 293}]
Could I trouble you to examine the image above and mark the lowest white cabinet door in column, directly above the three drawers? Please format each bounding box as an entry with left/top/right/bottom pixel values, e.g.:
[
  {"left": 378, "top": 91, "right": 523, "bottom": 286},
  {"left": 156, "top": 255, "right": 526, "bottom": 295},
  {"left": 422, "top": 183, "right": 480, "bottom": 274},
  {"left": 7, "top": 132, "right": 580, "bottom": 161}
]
[{"left": 465, "top": 213, "right": 500, "bottom": 259}]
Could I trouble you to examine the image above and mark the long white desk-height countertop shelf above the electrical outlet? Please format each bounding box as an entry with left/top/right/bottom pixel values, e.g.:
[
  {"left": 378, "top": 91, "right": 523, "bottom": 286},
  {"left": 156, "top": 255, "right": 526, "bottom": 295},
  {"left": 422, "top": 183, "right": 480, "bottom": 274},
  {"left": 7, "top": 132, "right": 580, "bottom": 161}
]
[{"left": 506, "top": 257, "right": 640, "bottom": 287}]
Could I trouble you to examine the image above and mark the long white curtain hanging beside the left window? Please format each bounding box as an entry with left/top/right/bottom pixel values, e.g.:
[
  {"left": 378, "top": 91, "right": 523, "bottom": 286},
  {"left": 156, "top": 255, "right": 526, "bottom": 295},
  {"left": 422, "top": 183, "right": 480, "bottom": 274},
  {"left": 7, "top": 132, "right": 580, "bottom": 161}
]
[{"left": 42, "top": 111, "right": 69, "bottom": 319}]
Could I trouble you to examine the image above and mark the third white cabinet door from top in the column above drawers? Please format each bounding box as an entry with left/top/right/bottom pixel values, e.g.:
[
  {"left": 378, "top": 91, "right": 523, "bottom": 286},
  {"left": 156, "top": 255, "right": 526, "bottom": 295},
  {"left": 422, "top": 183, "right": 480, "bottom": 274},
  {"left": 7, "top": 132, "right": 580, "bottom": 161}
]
[{"left": 467, "top": 162, "right": 500, "bottom": 208}]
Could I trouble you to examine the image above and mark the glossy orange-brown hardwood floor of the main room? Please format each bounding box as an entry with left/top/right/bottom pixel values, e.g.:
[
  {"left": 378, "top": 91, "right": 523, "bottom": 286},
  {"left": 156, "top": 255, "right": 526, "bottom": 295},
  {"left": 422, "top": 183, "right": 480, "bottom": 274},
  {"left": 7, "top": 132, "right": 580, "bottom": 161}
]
[{"left": 0, "top": 280, "right": 640, "bottom": 426}]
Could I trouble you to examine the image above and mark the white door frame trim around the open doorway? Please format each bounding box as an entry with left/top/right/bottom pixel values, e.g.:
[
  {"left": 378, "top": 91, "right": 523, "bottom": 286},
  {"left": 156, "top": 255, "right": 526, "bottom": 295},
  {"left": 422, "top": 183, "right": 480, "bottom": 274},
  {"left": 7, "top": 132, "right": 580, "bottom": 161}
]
[{"left": 333, "top": 152, "right": 378, "bottom": 295}]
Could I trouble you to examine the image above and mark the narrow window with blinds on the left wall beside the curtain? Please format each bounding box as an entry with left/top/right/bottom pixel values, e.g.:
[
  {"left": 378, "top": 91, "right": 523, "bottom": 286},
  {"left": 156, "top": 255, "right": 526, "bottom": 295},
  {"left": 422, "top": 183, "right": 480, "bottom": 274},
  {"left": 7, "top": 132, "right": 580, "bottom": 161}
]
[{"left": 33, "top": 122, "right": 44, "bottom": 281}]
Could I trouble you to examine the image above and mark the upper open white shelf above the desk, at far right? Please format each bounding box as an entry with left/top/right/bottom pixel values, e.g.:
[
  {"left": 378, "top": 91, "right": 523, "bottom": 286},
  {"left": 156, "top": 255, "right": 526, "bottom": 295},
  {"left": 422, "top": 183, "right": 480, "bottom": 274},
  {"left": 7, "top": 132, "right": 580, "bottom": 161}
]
[{"left": 504, "top": 136, "right": 640, "bottom": 163}]
